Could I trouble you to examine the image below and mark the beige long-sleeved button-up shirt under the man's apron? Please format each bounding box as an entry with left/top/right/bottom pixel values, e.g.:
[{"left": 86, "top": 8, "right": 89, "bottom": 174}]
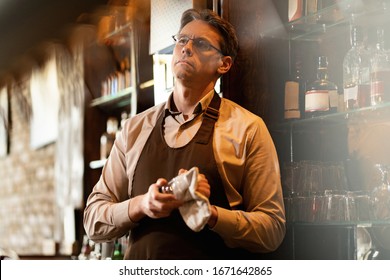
[{"left": 84, "top": 92, "right": 285, "bottom": 253}]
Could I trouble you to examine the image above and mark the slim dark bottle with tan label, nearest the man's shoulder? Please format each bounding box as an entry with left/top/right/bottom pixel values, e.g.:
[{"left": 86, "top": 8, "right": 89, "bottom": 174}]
[{"left": 284, "top": 61, "right": 303, "bottom": 120}]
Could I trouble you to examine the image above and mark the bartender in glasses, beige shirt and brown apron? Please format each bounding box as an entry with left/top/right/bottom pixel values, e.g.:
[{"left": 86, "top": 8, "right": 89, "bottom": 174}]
[{"left": 84, "top": 9, "right": 285, "bottom": 259}]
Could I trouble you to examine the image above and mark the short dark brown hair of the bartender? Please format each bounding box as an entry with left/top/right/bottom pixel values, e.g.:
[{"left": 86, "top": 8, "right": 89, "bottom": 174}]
[{"left": 179, "top": 9, "right": 238, "bottom": 60}]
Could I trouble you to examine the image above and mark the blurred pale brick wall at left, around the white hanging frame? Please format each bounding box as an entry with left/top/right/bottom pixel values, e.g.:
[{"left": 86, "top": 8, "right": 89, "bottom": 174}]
[{"left": 0, "top": 38, "right": 84, "bottom": 255}]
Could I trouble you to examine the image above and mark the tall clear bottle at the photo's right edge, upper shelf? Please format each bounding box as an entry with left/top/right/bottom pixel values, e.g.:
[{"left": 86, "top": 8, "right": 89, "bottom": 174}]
[{"left": 370, "top": 28, "right": 390, "bottom": 106}]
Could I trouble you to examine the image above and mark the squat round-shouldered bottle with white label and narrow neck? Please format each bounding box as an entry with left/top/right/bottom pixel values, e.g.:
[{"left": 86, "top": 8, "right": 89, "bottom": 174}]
[{"left": 305, "top": 56, "right": 338, "bottom": 118}]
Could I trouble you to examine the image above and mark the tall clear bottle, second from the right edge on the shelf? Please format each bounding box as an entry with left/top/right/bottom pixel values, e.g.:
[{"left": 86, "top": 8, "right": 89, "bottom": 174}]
[{"left": 343, "top": 26, "right": 370, "bottom": 111}]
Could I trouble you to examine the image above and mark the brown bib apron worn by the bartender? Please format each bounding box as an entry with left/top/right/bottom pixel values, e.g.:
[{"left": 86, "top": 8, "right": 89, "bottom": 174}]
[{"left": 125, "top": 93, "right": 256, "bottom": 260}]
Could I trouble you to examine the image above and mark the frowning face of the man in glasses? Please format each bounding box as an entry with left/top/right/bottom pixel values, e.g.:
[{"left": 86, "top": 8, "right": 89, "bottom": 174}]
[{"left": 172, "top": 20, "right": 222, "bottom": 85}]
